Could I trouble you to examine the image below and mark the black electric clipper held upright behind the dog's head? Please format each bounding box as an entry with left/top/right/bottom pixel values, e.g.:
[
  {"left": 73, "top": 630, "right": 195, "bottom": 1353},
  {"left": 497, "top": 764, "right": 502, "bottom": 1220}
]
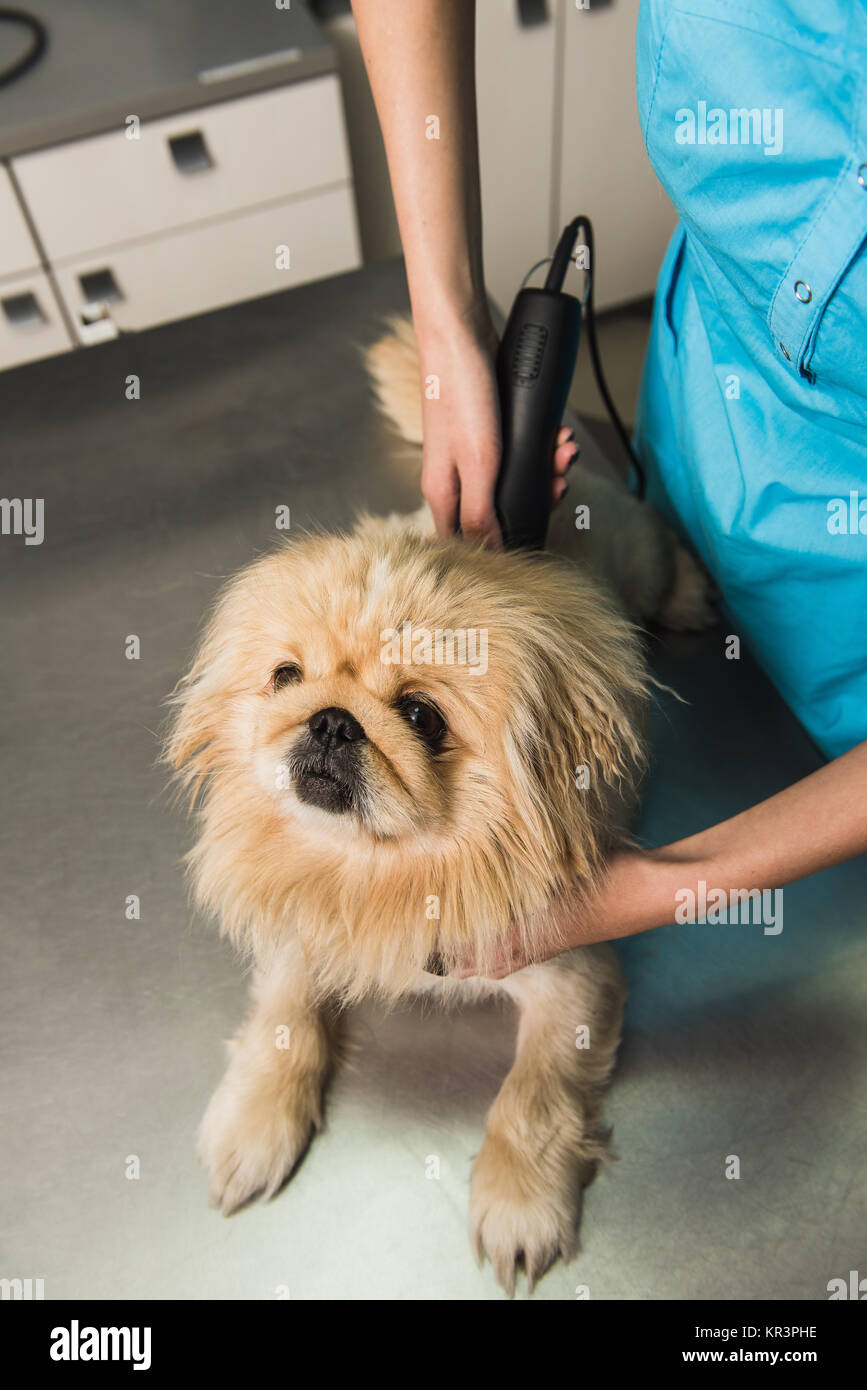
[{"left": 496, "top": 217, "right": 584, "bottom": 550}]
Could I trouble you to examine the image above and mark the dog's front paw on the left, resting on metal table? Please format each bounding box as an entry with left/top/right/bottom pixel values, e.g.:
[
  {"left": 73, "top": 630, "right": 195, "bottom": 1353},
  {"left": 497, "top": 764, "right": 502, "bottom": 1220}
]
[{"left": 199, "top": 1069, "right": 320, "bottom": 1216}]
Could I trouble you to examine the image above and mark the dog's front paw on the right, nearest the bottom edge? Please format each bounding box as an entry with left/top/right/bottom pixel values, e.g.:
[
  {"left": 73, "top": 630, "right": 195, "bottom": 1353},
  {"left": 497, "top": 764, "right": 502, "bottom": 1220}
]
[{"left": 470, "top": 1134, "right": 582, "bottom": 1298}]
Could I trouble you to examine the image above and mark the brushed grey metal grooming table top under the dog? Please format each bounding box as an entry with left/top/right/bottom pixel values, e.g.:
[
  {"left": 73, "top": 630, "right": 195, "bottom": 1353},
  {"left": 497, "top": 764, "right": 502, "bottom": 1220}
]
[{"left": 0, "top": 263, "right": 867, "bottom": 1300}]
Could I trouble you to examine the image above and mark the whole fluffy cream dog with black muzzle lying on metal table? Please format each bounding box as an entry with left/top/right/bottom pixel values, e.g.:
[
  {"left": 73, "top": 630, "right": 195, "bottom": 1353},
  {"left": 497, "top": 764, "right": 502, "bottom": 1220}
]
[{"left": 168, "top": 315, "right": 709, "bottom": 1293}]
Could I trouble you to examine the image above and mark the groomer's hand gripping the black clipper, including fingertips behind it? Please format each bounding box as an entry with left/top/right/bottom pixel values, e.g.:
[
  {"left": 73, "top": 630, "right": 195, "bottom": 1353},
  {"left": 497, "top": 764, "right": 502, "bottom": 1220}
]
[{"left": 415, "top": 306, "right": 578, "bottom": 546}]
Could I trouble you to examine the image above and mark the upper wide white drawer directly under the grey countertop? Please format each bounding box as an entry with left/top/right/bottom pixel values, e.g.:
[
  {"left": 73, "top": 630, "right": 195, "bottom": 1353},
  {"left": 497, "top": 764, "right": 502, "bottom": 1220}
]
[{"left": 13, "top": 75, "right": 350, "bottom": 263}]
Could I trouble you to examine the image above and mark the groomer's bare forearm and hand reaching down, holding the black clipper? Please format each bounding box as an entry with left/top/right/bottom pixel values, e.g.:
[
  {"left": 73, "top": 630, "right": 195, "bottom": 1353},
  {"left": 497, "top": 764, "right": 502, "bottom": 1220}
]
[{"left": 353, "top": 0, "right": 578, "bottom": 545}]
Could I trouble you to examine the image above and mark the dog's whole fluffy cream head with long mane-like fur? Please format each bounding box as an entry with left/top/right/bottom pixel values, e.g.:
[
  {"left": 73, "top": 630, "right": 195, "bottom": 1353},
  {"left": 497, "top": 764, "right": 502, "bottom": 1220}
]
[{"left": 170, "top": 521, "right": 643, "bottom": 976}]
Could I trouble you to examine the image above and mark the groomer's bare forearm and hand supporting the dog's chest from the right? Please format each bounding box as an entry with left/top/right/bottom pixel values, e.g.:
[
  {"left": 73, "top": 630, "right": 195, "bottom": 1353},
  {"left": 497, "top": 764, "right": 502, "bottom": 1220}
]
[{"left": 454, "top": 742, "right": 867, "bottom": 977}]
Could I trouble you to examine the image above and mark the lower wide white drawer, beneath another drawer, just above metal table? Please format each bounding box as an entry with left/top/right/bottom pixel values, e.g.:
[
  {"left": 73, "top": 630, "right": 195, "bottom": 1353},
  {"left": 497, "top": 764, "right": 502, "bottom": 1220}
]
[{"left": 54, "top": 185, "right": 360, "bottom": 343}]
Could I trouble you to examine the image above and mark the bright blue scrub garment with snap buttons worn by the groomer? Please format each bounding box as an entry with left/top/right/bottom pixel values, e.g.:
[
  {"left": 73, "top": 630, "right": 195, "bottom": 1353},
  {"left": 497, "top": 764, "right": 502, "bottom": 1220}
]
[{"left": 635, "top": 0, "right": 867, "bottom": 756}]
